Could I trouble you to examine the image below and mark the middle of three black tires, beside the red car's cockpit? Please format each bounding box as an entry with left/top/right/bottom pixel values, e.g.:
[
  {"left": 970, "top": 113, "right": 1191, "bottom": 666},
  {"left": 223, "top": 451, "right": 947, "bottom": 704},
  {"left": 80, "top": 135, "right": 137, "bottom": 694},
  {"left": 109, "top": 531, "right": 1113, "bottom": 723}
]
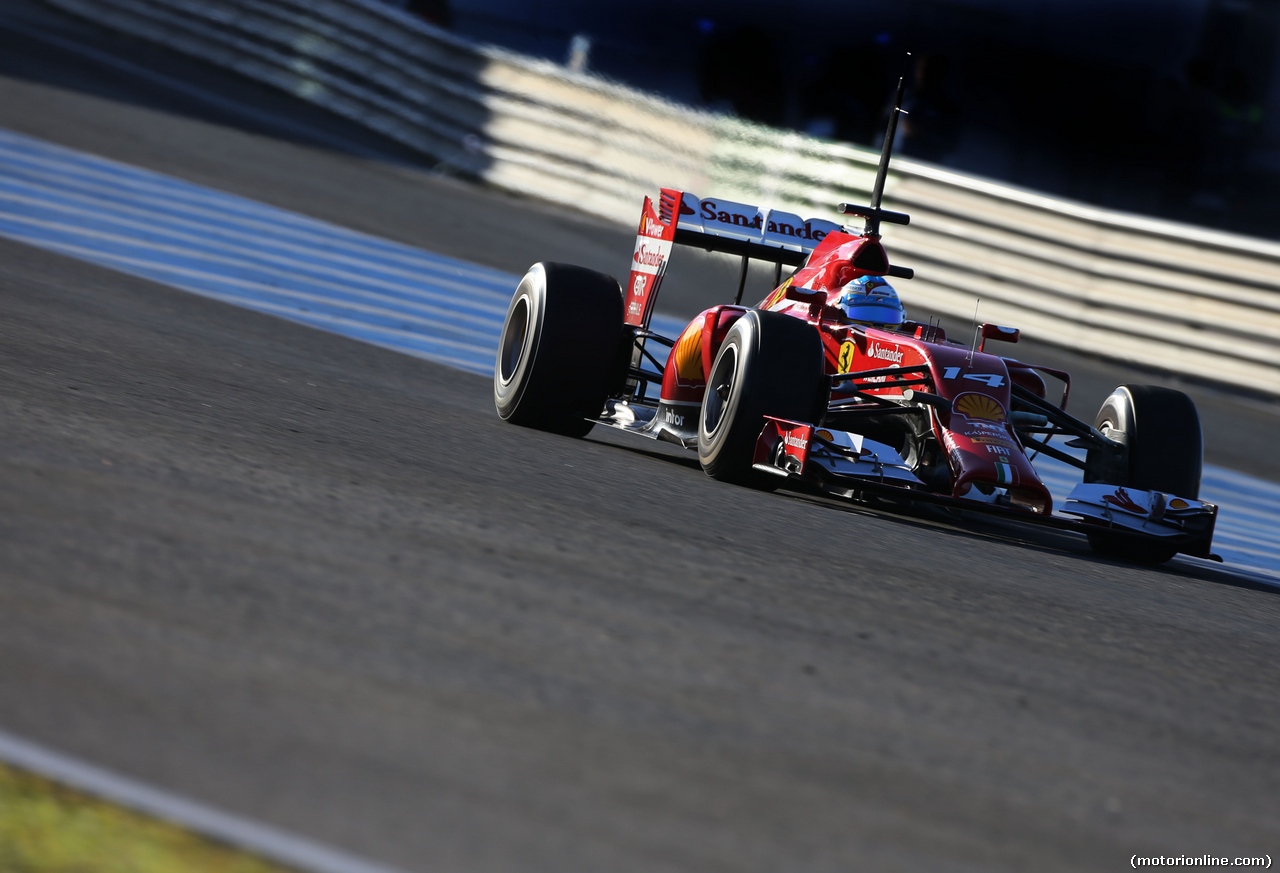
[{"left": 698, "top": 310, "right": 826, "bottom": 489}]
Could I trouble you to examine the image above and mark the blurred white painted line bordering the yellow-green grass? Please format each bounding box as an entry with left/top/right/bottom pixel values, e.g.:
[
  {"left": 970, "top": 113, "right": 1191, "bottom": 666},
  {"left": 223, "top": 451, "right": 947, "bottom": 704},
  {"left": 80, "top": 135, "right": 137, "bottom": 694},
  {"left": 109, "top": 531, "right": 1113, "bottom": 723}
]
[{"left": 0, "top": 730, "right": 402, "bottom": 873}]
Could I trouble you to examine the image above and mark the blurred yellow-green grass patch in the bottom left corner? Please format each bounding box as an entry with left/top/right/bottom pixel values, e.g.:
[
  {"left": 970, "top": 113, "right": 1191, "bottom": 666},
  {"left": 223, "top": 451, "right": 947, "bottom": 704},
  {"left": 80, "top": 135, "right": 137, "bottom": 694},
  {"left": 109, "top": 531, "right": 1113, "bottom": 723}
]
[{"left": 0, "top": 764, "right": 288, "bottom": 873}]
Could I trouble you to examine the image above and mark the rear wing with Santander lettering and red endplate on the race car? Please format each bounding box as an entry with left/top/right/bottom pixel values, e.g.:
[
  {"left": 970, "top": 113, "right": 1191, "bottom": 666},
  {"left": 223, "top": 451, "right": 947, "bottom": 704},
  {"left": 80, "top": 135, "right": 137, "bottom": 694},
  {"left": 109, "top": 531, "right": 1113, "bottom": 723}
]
[{"left": 626, "top": 188, "right": 844, "bottom": 328}]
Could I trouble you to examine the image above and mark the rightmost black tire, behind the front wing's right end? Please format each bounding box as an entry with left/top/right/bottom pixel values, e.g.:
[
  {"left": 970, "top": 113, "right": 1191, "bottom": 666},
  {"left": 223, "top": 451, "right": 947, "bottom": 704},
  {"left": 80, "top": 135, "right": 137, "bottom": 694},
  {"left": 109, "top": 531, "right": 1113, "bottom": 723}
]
[{"left": 1085, "top": 385, "right": 1204, "bottom": 563}]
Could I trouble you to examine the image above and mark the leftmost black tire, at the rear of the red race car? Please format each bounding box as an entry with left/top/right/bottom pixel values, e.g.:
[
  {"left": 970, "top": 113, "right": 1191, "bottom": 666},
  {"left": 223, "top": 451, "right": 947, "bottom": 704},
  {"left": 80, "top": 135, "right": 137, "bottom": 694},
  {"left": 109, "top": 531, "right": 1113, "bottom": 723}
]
[{"left": 493, "top": 262, "right": 622, "bottom": 437}]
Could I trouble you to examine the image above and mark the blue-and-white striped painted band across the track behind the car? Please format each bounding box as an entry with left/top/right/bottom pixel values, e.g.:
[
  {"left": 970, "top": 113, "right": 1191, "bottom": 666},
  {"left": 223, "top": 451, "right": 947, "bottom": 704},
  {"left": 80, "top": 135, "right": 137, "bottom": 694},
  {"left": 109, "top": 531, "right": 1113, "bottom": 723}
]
[{"left": 0, "top": 129, "right": 1280, "bottom": 582}]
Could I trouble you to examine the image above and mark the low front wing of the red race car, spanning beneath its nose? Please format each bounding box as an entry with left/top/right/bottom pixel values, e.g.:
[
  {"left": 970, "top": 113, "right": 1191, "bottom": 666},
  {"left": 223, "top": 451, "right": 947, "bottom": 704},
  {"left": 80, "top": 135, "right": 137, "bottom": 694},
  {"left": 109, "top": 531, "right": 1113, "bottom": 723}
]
[{"left": 754, "top": 417, "right": 1217, "bottom": 558}]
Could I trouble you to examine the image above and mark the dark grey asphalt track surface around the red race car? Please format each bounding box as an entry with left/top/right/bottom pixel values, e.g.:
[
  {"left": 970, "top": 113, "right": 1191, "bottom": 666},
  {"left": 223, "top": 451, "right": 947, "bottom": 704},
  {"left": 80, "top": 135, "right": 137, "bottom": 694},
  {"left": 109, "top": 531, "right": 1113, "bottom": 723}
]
[{"left": 0, "top": 6, "right": 1280, "bottom": 870}]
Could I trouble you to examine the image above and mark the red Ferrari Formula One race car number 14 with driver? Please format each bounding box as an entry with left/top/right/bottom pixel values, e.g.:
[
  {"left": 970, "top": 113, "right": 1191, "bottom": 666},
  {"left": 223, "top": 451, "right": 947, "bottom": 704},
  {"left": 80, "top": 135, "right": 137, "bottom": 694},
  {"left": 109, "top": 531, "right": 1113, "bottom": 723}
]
[{"left": 494, "top": 86, "right": 1217, "bottom": 563}]
